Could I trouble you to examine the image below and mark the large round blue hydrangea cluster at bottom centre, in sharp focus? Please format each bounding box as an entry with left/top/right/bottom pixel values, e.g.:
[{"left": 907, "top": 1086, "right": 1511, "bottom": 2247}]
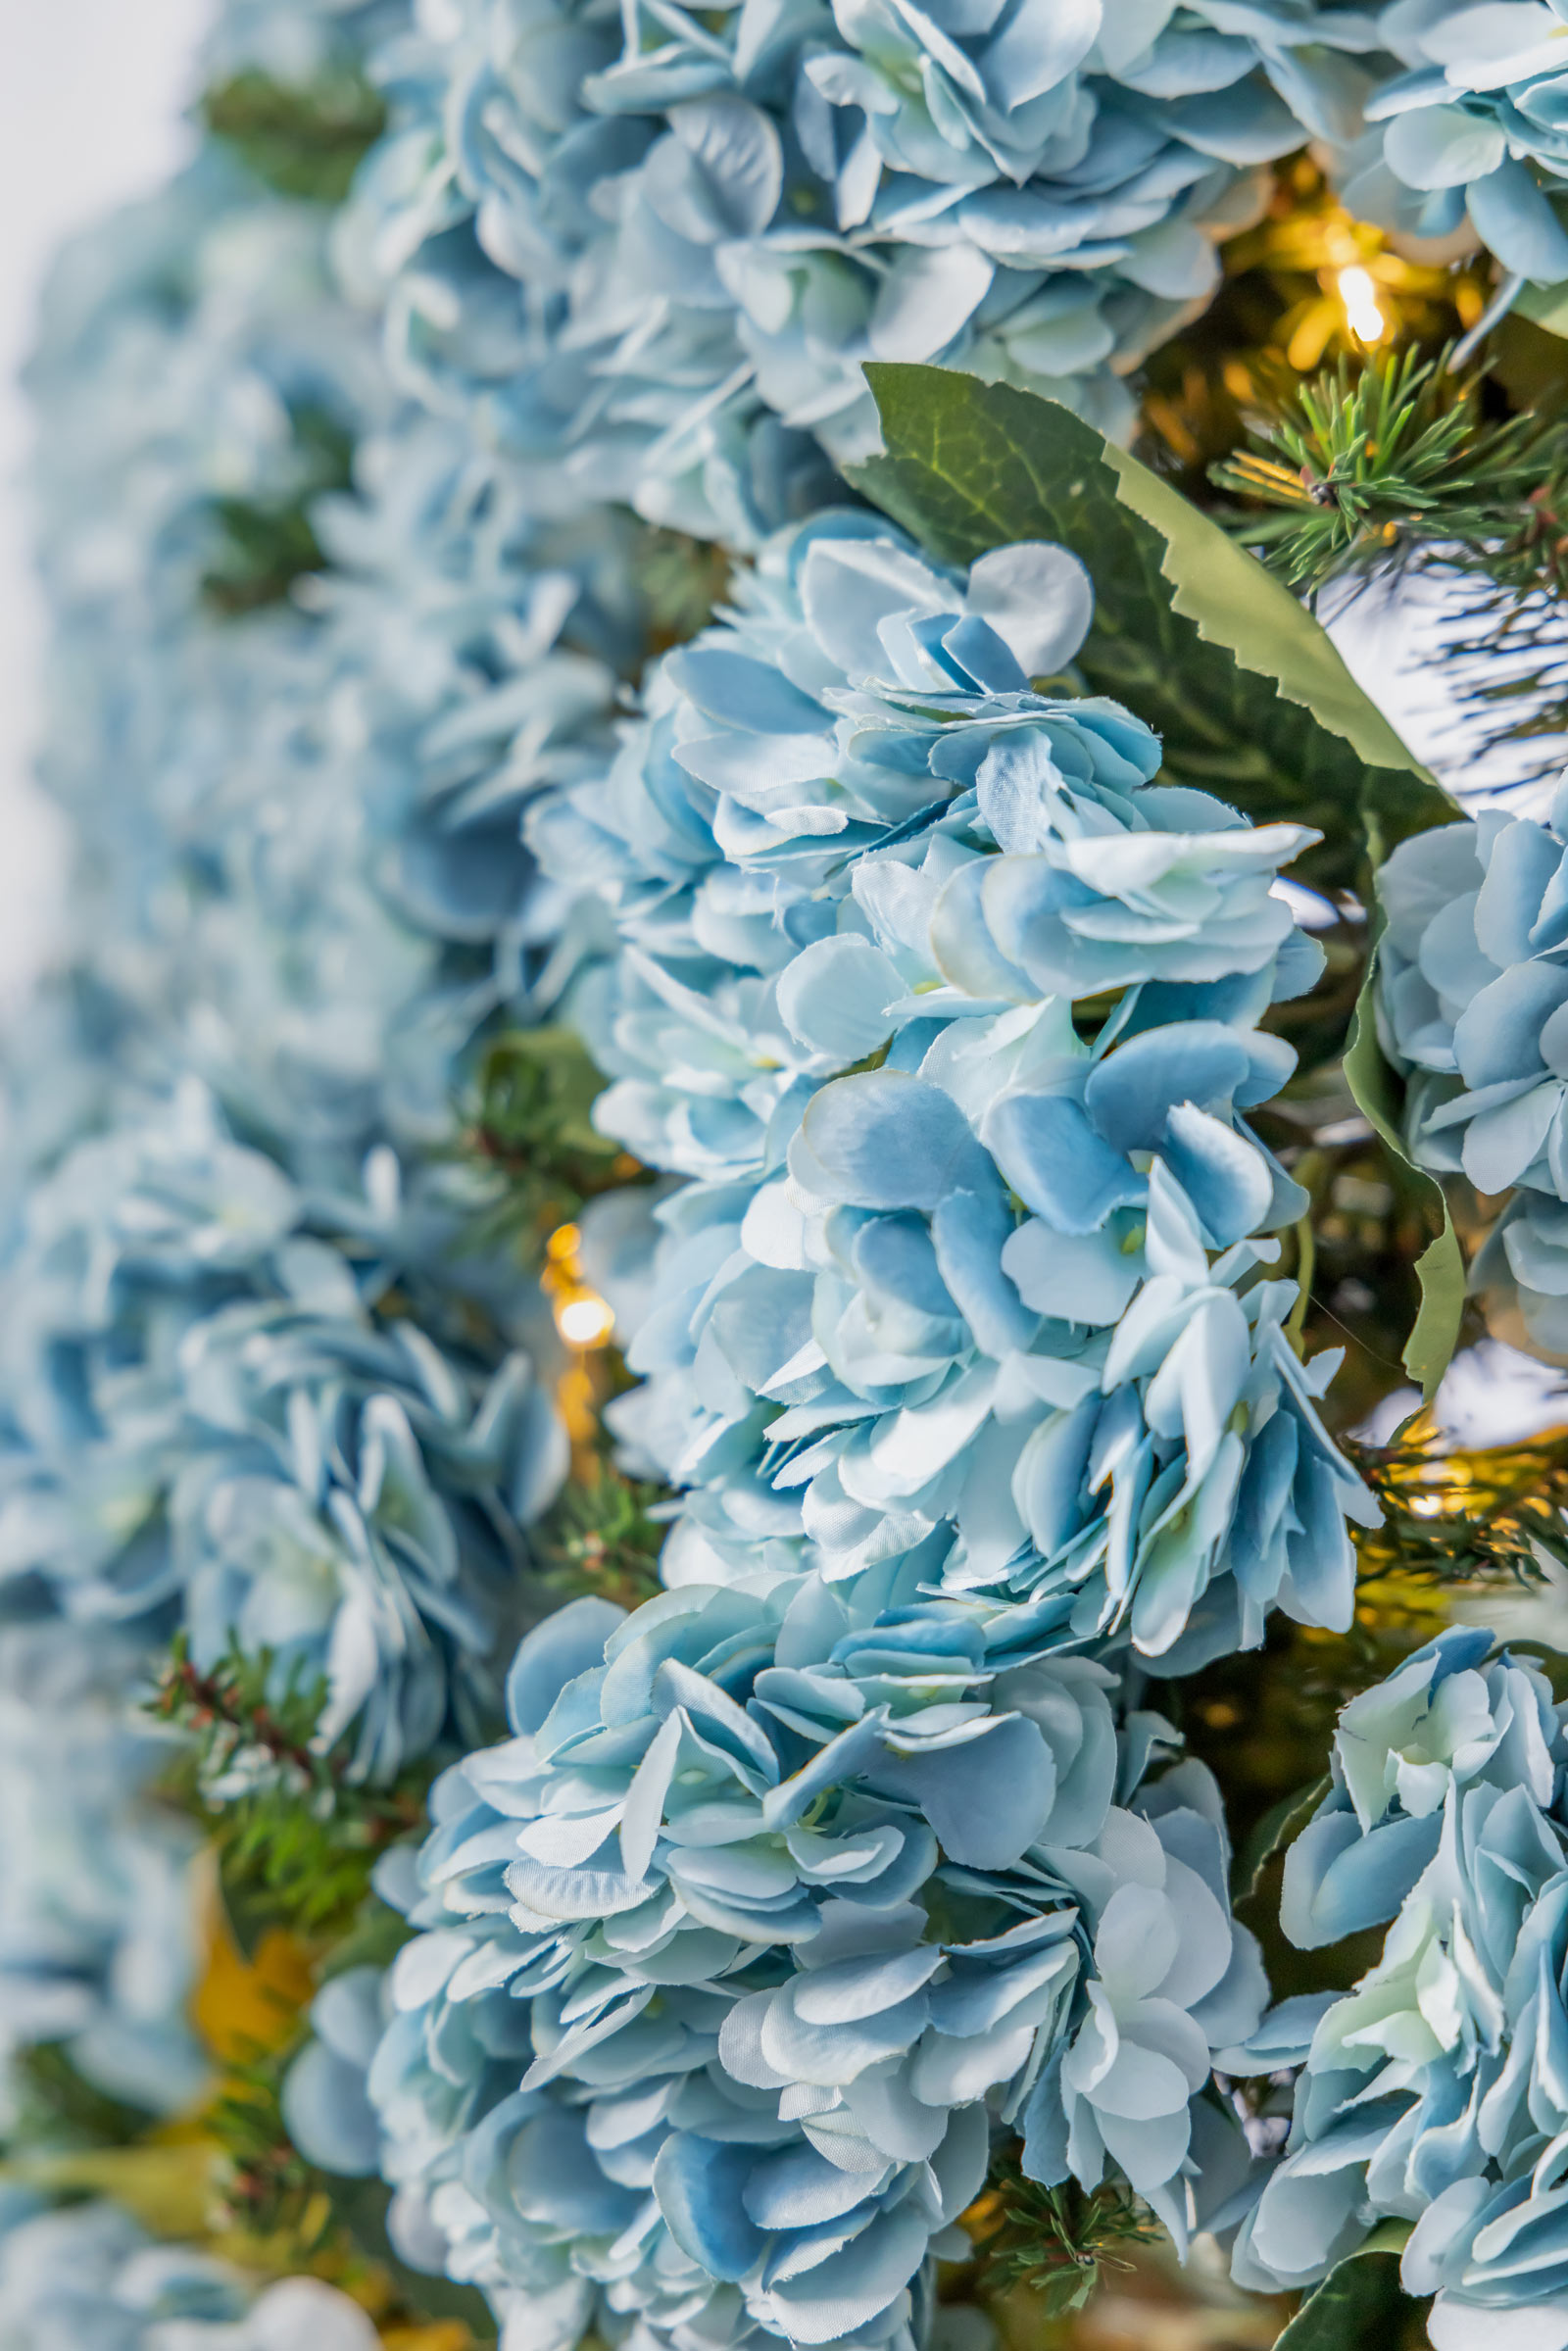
[{"left": 338, "top": 1571, "right": 1265, "bottom": 2351}]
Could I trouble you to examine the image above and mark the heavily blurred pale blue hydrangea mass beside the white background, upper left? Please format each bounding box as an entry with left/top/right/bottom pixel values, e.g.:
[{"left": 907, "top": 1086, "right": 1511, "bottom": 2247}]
[{"left": 35, "top": 160, "right": 639, "bottom": 1178}]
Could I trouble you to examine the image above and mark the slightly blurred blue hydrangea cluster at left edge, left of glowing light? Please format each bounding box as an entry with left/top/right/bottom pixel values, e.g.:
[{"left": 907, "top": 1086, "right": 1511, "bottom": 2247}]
[{"left": 0, "top": 1091, "right": 564, "bottom": 1775}]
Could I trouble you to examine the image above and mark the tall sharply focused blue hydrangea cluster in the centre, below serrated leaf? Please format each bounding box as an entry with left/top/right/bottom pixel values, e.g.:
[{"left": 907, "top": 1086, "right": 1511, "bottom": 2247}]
[{"left": 531, "top": 513, "right": 1368, "bottom": 1669}]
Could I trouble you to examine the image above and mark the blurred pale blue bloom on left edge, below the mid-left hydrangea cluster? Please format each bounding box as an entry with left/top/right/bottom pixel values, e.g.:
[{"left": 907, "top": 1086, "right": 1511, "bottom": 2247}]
[{"left": 0, "top": 1618, "right": 205, "bottom": 2125}]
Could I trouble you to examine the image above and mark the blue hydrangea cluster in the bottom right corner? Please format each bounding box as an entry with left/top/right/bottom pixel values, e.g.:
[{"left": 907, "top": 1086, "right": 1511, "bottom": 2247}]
[{"left": 1237, "top": 1630, "right": 1568, "bottom": 2351}]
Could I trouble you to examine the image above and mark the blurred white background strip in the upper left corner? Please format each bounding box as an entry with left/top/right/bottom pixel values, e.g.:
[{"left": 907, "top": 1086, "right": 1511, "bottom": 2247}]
[{"left": 0, "top": 0, "right": 207, "bottom": 1018}]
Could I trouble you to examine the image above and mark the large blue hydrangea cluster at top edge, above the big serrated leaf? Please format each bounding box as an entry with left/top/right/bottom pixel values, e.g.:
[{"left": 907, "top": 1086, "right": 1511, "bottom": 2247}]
[{"left": 343, "top": 0, "right": 1378, "bottom": 528}]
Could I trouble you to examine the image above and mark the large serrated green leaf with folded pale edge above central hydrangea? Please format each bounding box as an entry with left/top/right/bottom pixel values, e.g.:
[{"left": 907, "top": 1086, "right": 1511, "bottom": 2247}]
[{"left": 854, "top": 365, "right": 1457, "bottom": 889}]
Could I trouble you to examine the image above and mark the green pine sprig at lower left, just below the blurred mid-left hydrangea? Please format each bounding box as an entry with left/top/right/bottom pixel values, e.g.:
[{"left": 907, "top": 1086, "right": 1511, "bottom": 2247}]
[{"left": 151, "top": 1634, "right": 430, "bottom": 1946}]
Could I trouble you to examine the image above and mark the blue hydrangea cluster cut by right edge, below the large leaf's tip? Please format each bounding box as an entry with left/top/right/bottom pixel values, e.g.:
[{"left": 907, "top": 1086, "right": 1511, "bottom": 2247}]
[{"left": 1378, "top": 785, "right": 1568, "bottom": 1356}]
